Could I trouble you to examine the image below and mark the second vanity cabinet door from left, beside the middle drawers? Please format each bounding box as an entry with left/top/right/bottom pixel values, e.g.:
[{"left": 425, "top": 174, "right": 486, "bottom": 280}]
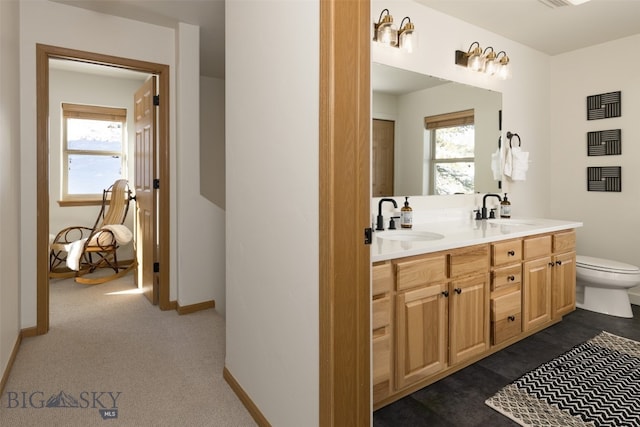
[{"left": 449, "top": 273, "right": 489, "bottom": 365}]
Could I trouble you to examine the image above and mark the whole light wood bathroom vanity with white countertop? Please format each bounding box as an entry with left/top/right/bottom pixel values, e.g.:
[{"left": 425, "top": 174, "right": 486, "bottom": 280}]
[{"left": 372, "top": 219, "right": 582, "bottom": 410}]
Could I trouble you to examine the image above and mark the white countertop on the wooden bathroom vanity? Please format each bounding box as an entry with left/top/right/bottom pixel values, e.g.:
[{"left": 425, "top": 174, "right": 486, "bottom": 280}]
[{"left": 371, "top": 218, "right": 582, "bottom": 262}]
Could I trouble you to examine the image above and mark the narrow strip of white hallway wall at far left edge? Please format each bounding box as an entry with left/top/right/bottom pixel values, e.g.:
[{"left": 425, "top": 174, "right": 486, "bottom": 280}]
[{"left": 0, "top": 1, "right": 20, "bottom": 378}]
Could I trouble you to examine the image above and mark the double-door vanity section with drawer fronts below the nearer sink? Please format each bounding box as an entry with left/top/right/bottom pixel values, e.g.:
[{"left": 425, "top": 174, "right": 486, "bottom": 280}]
[{"left": 396, "top": 245, "right": 489, "bottom": 389}]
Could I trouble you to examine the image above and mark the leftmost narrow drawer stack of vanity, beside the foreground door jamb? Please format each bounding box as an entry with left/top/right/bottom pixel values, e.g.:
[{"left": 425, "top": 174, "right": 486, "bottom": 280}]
[{"left": 371, "top": 261, "right": 395, "bottom": 403}]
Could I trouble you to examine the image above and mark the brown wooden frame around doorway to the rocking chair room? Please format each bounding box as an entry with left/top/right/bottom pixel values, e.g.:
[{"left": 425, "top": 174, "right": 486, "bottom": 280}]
[{"left": 36, "top": 44, "right": 173, "bottom": 335}]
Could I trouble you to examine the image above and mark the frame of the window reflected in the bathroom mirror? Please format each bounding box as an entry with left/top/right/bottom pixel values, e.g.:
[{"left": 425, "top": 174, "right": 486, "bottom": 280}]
[{"left": 424, "top": 109, "right": 475, "bottom": 195}]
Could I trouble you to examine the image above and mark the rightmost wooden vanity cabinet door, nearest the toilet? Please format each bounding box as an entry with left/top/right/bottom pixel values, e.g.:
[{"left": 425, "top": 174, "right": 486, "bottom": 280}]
[{"left": 551, "top": 252, "right": 576, "bottom": 318}]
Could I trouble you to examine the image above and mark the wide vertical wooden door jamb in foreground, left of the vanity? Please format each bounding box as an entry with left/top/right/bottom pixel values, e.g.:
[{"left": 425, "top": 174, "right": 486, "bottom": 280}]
[{"left": 319, "top": 0, "right": 372, "bottom": 427}]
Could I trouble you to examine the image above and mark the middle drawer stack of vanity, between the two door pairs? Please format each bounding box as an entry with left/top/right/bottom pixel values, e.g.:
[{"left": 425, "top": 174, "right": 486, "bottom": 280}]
[{"left": 491, "top": 239, "right": 522, "bottom": 345}]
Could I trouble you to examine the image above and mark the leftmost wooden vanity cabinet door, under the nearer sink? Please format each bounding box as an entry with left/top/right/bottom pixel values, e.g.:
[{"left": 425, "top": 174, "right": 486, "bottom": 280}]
[{"left": 396, "top": 282, "right": 447, "bottom": 389}]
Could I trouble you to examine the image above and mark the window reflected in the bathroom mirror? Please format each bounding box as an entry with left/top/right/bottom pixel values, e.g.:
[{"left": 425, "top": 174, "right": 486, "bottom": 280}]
[{"left": 425, "top": 110, "right": 475, "bottom": 194}]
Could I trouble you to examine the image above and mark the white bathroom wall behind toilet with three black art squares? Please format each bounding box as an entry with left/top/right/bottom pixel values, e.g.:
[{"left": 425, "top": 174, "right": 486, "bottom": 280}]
[{"left": 549, "top": 34, "right": 640, "bottom": 304}]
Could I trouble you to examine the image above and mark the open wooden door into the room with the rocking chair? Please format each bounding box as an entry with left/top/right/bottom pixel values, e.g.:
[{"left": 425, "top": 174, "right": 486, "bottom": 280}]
[{"left": 134, "top": 76, "right": 158, "bottom": 304}]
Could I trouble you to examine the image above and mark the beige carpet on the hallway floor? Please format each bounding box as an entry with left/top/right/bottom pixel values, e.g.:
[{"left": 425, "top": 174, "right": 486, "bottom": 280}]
[{"left": 0, "top": 276, "right": 255, "bottom": 427}]
